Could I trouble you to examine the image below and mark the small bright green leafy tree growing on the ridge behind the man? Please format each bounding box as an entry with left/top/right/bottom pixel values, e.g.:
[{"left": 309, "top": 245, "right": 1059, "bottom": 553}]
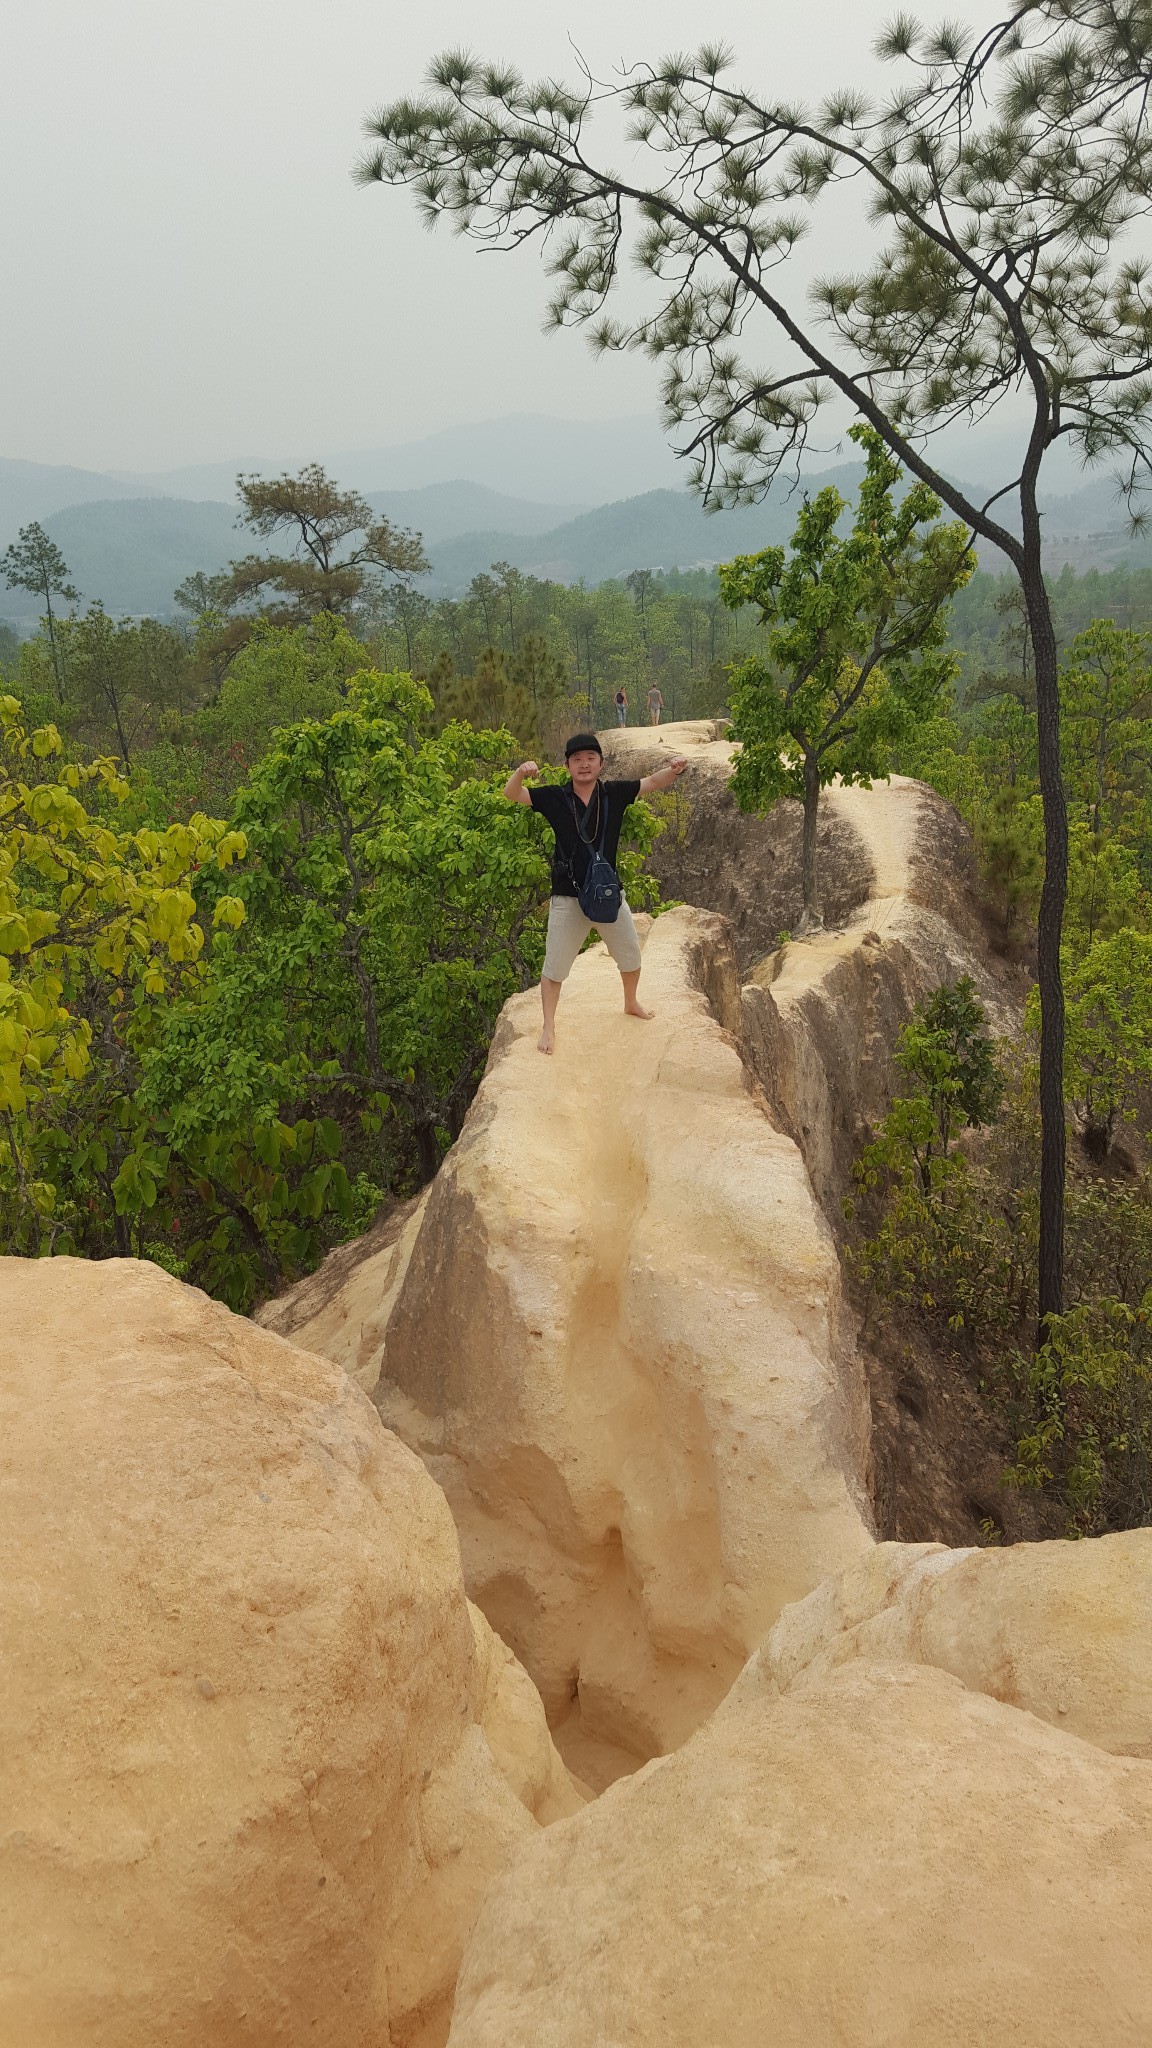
[{"left": 719, "top": 426, "right": 963, "bottom": 930}]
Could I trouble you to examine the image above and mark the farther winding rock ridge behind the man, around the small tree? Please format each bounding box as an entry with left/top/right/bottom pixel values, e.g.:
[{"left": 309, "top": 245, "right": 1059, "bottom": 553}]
[{"left": 603, "top": 719, "right": 1021, "bottom": 1229}]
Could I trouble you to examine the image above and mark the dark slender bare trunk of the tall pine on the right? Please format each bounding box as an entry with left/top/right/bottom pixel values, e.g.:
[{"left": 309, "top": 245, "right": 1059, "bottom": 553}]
[{"left": 1021, "top": 552, "right": 1068, "bottom": 1341}]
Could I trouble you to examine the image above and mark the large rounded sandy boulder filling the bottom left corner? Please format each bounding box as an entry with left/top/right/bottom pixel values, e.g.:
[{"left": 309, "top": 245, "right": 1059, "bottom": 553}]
[{"left": 0, "top": 1260, "right": 553, "bottom": 2048}]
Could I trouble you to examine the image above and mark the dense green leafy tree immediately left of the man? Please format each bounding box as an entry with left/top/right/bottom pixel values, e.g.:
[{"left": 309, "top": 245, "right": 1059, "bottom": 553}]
[{"left": 148, "top": 672, "right": 627, "bottom": 1188}]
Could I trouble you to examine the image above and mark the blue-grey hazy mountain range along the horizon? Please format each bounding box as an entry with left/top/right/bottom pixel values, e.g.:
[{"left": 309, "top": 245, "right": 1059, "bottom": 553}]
[{"left": 0, "top": 414, "right": 1150, "bottom": 614}]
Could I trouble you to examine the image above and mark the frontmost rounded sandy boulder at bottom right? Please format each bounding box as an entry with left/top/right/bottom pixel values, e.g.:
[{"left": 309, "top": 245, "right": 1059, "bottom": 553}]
[{"left": 451, "top": 1663, "right": 1152, "bottom": 2048}]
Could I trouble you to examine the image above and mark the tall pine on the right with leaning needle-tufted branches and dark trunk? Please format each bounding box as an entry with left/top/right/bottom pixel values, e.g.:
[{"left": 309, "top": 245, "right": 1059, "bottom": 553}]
[{"left": 361, "top": 0, "right": 1152, "bottom": 1321}]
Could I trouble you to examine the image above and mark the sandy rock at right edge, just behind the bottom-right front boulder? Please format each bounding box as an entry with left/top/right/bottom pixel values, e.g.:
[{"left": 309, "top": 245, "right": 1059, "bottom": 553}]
[{"left": 758, "top": 1528, "right": 1152, "bottom": 1757}]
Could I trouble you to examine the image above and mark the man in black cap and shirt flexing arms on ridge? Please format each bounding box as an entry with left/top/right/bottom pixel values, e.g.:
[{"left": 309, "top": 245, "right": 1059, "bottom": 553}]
[{"left": 504, "top": 733, "right": 689, "bottom": 1053}]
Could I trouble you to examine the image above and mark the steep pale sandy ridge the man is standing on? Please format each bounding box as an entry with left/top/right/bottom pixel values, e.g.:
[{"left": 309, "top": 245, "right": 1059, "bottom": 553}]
[{"left": 373, "top": 909, "right": 871, "bottom": 1784}]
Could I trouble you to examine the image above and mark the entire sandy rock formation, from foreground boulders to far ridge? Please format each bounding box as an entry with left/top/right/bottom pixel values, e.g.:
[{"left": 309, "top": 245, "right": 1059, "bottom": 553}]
[{"left": 11, "top": 725, "right": 1152, "bottom": 2048}]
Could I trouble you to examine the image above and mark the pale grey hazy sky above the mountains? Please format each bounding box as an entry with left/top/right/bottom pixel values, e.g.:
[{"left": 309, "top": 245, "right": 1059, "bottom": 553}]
[{"left": 0, "top": 0, "right": 990, "bottom": 469}]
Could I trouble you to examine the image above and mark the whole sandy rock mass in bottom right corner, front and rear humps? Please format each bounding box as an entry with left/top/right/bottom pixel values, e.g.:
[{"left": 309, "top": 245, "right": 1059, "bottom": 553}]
[{"left": 451, "top": 1530, "right": 1152, "bottom": 2048}]
